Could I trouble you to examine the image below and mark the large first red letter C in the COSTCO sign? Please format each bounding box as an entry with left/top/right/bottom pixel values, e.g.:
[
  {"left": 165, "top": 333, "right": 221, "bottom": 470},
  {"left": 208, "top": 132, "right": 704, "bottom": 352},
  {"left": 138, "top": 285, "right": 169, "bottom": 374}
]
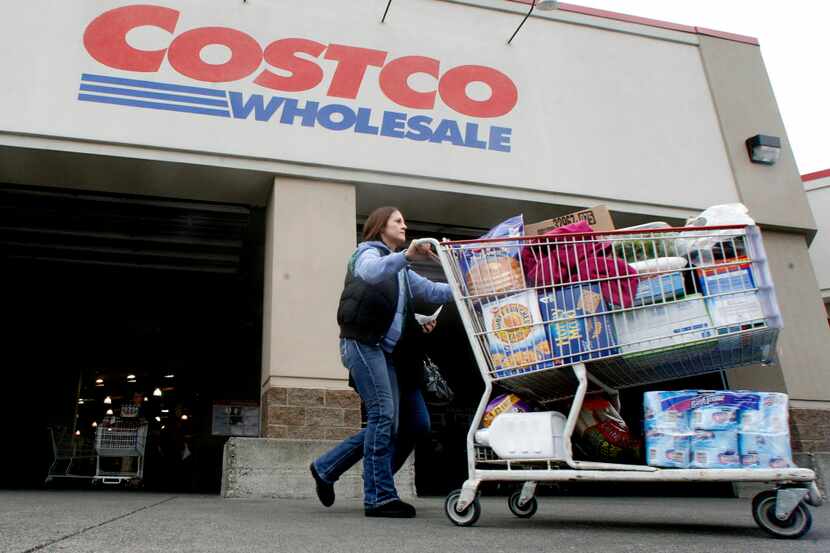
[{"left": 84, "top": 6, "right": 179, "bottom": 73}]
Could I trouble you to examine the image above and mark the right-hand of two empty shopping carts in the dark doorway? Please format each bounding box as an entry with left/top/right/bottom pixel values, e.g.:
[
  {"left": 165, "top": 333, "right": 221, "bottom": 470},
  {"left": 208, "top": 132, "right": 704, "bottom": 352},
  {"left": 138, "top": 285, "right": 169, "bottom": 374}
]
[{"left": 93, "top": 417, "right": 147, "bottom": 484}]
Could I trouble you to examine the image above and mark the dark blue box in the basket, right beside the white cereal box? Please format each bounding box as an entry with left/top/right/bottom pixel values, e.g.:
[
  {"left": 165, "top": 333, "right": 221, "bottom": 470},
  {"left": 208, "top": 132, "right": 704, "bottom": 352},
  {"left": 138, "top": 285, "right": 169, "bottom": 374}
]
[{"left": 539, "top": 284, "right": 619, "bottom": 364}]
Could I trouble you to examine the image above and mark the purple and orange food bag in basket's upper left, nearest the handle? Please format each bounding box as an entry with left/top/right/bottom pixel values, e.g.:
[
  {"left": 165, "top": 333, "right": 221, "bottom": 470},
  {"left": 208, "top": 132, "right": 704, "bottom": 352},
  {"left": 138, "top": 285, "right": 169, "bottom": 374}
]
[{"left": 460, "top": 215, "right": 525, "bottom": 296}]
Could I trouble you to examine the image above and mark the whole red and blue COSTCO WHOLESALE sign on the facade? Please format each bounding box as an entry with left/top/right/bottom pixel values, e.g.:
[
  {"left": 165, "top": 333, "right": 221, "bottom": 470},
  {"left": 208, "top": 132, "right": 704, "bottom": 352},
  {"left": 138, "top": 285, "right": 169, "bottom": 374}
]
[{"left": 78, "top": 5, "right": 519, "bottom": 152}]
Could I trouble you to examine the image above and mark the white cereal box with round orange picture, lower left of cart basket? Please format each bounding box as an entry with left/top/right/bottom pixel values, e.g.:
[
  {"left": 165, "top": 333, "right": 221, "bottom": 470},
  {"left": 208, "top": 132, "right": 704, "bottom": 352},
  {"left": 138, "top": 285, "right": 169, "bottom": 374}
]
[{"left": 481, "top": 290, "right": 553, "bottom": 378}]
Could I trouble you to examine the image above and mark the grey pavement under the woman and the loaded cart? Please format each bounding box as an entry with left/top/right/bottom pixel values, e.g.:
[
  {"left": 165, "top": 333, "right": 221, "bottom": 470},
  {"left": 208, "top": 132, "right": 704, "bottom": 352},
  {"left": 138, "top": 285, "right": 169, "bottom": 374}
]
[{"left": 0, "top": 490, "right": 830, "bottom": 553}]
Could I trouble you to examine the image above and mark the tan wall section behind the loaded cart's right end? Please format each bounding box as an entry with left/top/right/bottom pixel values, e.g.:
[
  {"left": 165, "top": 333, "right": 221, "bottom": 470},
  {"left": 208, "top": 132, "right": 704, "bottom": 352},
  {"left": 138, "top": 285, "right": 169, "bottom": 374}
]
[{"left": 729, "top": 230, "right": 830, "bottom": 401}]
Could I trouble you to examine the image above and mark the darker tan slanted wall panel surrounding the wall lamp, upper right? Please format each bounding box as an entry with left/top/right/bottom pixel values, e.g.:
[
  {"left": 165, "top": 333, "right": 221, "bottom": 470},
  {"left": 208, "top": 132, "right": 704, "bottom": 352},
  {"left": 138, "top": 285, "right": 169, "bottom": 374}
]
[{"left": 700, "top": 36, "right": 815, "bottom": 230}]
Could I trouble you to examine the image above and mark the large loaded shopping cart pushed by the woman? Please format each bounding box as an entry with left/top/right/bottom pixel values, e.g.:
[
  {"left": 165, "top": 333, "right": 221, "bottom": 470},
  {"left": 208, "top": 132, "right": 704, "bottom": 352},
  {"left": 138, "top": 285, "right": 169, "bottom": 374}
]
[{"left": 426, "top": 225, "right": 822, "bottom": 538}]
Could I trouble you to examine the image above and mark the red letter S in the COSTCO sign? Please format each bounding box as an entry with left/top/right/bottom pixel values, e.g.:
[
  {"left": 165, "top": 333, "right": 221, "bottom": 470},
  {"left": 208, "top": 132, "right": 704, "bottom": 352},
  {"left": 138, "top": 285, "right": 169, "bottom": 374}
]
[{"left": 254, "top": 38, "right": 326, "bottom": 92}]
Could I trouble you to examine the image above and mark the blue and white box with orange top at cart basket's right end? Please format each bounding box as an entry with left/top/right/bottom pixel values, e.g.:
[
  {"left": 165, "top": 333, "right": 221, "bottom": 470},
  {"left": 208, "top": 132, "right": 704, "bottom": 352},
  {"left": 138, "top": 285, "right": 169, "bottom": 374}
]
[{"left": 697, "top": 257, "right": 764, "bottom": 334}]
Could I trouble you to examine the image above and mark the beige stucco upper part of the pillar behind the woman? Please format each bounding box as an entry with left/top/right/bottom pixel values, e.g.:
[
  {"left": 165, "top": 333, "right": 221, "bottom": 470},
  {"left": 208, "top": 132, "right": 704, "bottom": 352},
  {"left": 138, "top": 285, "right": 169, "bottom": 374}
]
[{"left": 262, "top": 177, "right": 357, "bottom": 389}]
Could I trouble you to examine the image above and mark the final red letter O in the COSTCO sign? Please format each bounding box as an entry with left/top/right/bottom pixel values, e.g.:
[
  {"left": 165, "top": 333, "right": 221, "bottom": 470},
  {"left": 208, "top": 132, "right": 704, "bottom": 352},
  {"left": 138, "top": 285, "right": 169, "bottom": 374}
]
[{"left": 438, "top": 65, "right": 519, "bottom": 117}]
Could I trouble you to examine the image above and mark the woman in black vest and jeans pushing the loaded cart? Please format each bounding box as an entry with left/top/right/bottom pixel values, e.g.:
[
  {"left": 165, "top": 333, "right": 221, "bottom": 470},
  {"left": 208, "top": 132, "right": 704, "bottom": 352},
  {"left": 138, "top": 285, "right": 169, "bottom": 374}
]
[{"left": 310, "top": 207, "right": 452, "bottom": 518}]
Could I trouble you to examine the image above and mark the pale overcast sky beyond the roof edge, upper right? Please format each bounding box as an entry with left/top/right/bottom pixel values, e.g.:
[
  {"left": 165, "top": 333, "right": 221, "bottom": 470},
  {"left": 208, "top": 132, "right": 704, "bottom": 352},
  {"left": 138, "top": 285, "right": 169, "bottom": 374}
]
[{"left": 569, "top": 0, "right": 830, "bottom": 175}]
